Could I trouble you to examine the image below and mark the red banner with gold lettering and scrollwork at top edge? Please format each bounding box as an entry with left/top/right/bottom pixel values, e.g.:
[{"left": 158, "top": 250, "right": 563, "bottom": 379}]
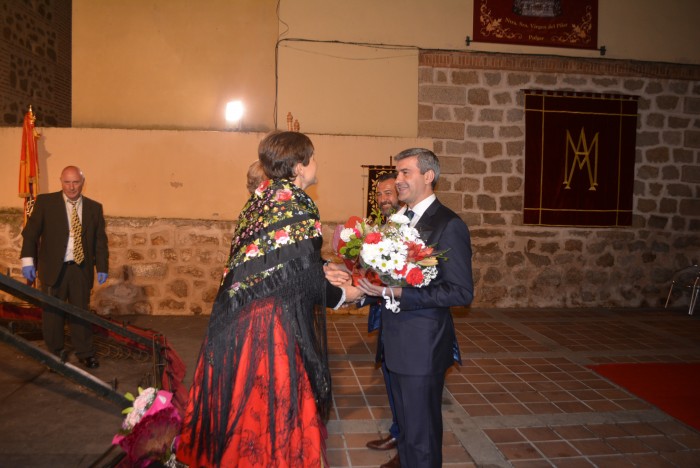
[{"left": 474, "top": 0, "right": 598, "bottom": 49}]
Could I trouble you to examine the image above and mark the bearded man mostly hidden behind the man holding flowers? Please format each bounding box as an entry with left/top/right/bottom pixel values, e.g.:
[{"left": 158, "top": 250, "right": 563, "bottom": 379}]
[{"left": 367, "top": 171, "right": 401, "bottom": 468}]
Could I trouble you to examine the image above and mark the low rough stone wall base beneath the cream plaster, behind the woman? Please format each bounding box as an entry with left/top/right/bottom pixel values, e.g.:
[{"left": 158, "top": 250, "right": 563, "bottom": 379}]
[{"left": 0, "top": 211, "right": 342, "bottom": 315}]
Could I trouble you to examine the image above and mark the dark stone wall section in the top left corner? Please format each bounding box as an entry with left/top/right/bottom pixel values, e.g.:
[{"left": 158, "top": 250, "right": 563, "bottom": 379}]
[{"left": 0, "top": 0, "right": 73, "bottom": 127}]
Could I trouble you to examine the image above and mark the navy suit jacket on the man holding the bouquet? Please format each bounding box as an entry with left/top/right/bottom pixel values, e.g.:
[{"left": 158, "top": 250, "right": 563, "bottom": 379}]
[{"left": 382, "top": 200, "right": 474, "bottom": 375}]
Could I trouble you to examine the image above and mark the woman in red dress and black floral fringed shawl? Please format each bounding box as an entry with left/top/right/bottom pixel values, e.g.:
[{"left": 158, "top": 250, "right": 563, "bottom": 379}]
[{"left": 176, "top": 132, "right": 360, "bottom": 467}]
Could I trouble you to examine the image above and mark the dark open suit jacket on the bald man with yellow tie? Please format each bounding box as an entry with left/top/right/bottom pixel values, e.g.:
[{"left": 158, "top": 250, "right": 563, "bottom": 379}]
[{"left": 20, "top": 192, "right": 109, "bottom": 287}]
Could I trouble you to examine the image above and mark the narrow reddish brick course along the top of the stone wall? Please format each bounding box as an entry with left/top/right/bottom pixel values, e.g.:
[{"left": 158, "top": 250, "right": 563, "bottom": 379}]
[{"left": 419, "top": 50, "right": 700, "bottom": 81}]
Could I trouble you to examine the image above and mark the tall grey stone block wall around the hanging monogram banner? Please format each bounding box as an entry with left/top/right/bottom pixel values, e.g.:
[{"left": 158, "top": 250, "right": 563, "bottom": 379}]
[{"left": 418, "top": 52, "right": 700, "bottom": 307}]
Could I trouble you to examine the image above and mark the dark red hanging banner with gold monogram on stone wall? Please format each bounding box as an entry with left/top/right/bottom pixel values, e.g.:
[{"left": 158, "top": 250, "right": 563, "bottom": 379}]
[{"left": 523, "top": 90, "right": 638, "bottom": 227}]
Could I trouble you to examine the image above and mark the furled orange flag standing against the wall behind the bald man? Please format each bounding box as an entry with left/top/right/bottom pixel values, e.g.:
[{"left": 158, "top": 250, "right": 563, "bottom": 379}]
[{"left": 19, "top": 106, "right": 41, "bottom": 224}]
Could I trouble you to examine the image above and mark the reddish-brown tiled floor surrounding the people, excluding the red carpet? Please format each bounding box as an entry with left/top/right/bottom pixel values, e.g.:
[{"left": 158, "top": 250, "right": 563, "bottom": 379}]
[{"left": 0, "top": 309, "right": 700, "bottom": 468}]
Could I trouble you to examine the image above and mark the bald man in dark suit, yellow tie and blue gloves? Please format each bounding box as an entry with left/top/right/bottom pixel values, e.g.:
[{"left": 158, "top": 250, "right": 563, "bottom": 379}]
[{"left": 20, "top": 166, "right": 109, "bottom": 369}]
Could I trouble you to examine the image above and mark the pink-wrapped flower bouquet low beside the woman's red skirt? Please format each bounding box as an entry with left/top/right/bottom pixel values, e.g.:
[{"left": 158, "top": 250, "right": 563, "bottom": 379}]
[{"left": 112, "top": 387, "right": 181, "bottom": 468}]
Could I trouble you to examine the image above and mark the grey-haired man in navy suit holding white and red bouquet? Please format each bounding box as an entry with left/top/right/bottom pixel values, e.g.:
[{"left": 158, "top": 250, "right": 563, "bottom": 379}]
[{"left": 360, "top": 148, "right": 474, "bottom": 468}]
